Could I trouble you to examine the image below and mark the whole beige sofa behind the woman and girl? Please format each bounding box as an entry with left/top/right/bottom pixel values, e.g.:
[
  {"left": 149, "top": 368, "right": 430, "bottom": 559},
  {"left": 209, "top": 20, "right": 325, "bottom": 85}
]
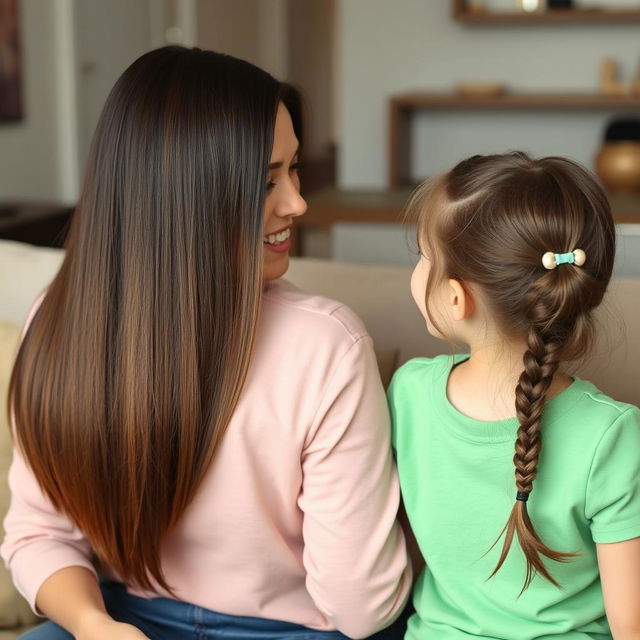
[{"left": 0, "top": 240, "right": 640, "bottom": 640}]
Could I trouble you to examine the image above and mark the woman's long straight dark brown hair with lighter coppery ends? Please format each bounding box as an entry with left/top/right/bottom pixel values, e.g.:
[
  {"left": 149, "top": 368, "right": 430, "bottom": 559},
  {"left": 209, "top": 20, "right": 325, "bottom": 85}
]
[{"left": 9, "top": 47, "right": 300, "bottom": 591}]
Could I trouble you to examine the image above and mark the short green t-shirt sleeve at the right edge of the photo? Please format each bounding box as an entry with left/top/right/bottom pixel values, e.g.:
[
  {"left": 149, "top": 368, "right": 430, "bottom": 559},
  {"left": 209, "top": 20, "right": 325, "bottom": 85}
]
[{"left": 585, "top": 407, "right": 640, "bottom": 543}]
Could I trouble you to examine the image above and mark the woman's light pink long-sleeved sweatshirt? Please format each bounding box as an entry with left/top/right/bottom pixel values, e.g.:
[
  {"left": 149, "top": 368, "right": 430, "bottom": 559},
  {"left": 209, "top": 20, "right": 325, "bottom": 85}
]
[{"left": 0, "top": 280, "right": 411, "bottom": 638}]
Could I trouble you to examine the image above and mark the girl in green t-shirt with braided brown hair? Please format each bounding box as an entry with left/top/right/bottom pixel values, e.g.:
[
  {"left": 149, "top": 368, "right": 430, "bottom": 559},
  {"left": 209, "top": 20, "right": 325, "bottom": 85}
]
[{"left": 389, "top": 153, "right": 640, "bottom": 640}]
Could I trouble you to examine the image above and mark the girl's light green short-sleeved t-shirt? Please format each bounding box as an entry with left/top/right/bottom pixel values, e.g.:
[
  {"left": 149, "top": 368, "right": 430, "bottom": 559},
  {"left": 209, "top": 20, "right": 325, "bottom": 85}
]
[{"left": 389, "top": 356, "right": 640, "bottom": 640}]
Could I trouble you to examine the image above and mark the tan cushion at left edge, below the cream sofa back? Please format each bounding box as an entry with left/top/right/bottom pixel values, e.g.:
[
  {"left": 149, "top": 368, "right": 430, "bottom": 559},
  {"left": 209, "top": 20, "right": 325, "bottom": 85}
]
[{"left": 0, "top": 323, "right": 36, "bottom": 637}]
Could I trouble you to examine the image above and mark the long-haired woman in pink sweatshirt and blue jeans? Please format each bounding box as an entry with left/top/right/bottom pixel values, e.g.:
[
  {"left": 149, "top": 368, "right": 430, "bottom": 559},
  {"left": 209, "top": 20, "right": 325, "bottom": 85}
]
[{"left": 2, "top": 47, "right": 411, "bottom": 640}]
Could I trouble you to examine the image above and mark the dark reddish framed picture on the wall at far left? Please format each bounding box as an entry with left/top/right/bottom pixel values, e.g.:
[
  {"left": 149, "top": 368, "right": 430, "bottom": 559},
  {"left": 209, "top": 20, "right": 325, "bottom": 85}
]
[{"left": 0, "top": 0, "right": 22, "bottom": 123}]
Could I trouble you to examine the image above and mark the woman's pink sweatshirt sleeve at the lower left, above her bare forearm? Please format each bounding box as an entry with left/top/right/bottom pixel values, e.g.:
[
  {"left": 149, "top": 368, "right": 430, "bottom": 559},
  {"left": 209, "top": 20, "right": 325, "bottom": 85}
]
[{"left": 0, "top": 448, "right": 95, "bottom": 615}]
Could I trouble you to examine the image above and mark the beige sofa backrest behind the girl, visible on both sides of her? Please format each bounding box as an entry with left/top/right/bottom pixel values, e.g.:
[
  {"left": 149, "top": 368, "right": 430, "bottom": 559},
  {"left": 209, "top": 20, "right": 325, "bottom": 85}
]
[{"left": 286, "top": 258, "right": 640, "bottom": 405}]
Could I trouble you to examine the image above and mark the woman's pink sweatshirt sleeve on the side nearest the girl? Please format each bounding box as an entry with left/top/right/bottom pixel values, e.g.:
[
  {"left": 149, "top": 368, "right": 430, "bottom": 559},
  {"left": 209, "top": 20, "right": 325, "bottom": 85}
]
[{"left": 299, "top": 336, "right": 411, "bottom": 638}]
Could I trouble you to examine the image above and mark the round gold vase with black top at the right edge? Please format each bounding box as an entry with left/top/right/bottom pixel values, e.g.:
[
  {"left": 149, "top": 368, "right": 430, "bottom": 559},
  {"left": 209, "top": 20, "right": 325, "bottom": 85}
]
[{"left": 596, "top": 117, "right": 640, "bottom": 193}]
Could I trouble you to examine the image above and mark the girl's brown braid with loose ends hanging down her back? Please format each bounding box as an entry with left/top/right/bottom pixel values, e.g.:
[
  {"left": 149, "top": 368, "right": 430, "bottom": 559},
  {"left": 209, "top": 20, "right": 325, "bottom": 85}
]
[{"left": 489, "top": 323, "right": 576, "bottom": 593}]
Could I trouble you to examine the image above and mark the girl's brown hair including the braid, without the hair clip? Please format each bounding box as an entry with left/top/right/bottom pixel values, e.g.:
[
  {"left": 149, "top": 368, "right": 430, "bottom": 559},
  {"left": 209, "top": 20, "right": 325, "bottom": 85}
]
[{"left": 409, "top": 153, "right": 615, "bottom": 591}]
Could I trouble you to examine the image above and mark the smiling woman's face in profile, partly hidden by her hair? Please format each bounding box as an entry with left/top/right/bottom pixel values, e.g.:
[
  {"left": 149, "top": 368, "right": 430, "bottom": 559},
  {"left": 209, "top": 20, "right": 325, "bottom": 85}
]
[{"left": 262, "top": 103, "right": 307, "bottom": 280}]
